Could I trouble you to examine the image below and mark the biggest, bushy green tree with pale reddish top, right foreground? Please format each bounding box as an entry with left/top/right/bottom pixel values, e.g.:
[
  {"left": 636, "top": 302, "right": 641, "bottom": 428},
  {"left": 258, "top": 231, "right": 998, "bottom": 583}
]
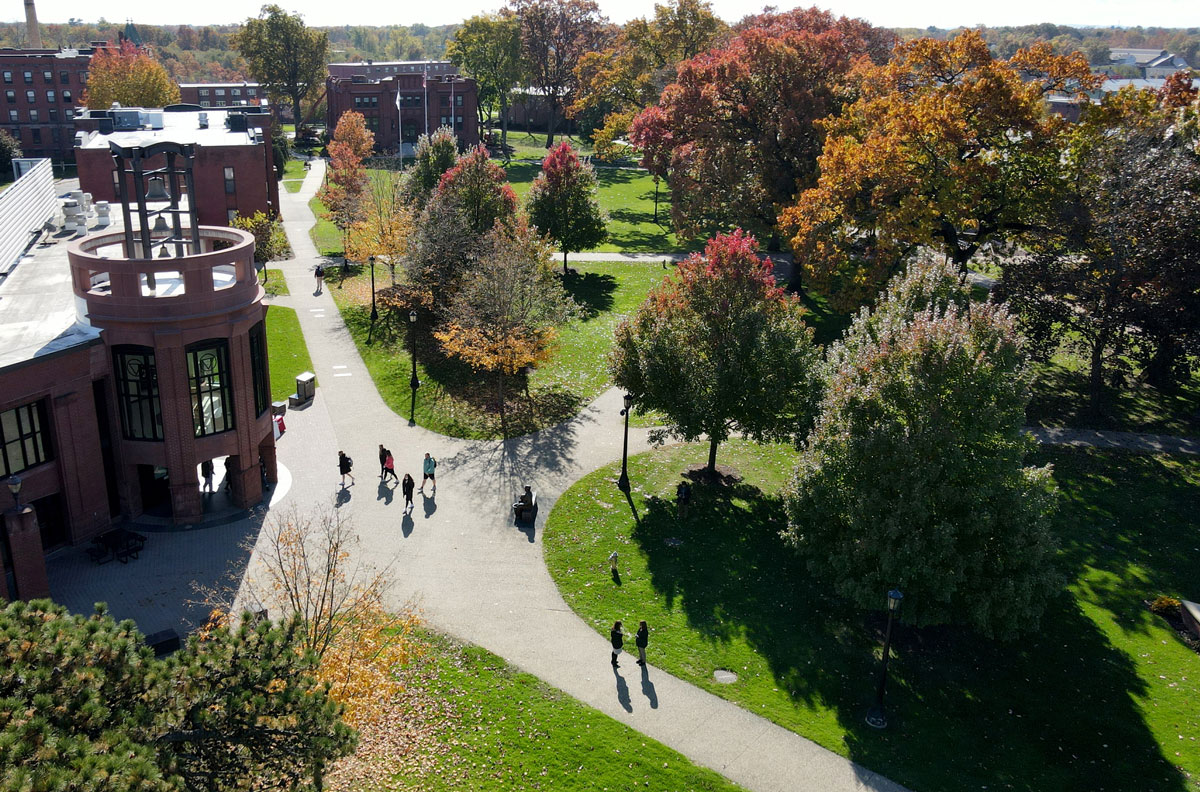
[{"left": 786, "top": 259, "right": 1061, "bottom": 637}]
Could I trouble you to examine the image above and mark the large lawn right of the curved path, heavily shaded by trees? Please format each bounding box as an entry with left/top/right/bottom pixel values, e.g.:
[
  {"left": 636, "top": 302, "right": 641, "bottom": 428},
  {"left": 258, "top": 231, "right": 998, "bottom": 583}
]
[{"left": 545, "top": 442, "right": 1200, "bottom": 792}]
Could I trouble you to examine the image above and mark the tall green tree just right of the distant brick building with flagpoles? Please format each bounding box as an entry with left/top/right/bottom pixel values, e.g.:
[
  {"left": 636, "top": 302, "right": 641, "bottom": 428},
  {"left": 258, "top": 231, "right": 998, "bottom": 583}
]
[{"left": 446, "top": 8, "right": 522, "bottom": 152}]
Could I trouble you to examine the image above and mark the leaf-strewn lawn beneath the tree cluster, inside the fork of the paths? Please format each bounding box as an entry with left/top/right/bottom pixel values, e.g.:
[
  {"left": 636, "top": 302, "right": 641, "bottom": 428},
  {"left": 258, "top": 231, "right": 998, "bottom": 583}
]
[{"left": 326, "top": 262, "right": 667, "bottom": 438}]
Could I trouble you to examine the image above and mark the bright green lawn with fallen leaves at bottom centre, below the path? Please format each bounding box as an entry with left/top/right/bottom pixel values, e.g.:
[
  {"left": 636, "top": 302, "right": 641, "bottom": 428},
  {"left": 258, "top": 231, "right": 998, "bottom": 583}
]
[{"left": 396, "top": 636, "right": 742, "bottom": 792}]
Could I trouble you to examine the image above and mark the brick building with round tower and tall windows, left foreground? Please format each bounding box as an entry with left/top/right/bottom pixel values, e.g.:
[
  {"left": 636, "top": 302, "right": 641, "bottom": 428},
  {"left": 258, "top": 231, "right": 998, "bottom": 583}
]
[{"left": 0, "top": 154, "right": 276, "bottom": 601}]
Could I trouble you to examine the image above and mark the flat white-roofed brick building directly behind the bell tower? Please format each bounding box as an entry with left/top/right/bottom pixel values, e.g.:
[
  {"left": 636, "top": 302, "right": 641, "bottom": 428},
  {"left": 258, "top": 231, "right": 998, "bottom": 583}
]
[{"left": 76, "top": 108, "right": 280, "bottom": 226}]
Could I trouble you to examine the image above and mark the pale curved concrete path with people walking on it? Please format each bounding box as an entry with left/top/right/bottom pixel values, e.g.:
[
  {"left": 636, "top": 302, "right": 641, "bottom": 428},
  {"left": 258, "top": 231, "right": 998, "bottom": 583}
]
[{"left": 278, "top": 161, "right": 904, "bottom": 792}]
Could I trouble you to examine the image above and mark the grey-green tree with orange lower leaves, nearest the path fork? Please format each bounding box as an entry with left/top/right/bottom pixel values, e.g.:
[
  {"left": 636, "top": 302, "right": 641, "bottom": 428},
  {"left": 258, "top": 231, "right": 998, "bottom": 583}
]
[{"left": 433, "top": 218, "right": 577, "bottom": 415}]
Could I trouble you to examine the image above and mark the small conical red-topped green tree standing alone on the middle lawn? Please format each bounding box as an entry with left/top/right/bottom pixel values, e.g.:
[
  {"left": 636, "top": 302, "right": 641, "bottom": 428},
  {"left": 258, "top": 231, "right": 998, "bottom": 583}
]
[{"left": 526, "top": 140, "right": 608, "bottom": 276}]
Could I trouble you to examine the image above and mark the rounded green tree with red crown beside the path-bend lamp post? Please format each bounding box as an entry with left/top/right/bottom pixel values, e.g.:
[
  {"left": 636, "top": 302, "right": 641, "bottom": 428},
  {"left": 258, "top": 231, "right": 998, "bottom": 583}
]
[{"left": 608, "top": 229, "right": 820, "bottom": 473}]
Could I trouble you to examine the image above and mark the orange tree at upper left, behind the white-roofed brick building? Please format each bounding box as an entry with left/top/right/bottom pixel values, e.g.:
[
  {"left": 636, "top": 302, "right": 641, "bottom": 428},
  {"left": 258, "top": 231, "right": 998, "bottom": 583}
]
[{"left": 83, "top": 41, "right": 179, "bottom": 110}]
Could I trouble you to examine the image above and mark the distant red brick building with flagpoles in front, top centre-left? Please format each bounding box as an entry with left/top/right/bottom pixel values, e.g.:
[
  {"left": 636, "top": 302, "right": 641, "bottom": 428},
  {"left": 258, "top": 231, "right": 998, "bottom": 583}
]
[{"left": 325, "top": 61, "right": 479, "bottom": 156}]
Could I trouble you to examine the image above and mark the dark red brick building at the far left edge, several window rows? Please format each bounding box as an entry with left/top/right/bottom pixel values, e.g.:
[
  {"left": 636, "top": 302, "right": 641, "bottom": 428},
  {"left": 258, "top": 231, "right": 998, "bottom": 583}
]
[{"left": 0, "top": 48, "right": 95, "bottom": 162}]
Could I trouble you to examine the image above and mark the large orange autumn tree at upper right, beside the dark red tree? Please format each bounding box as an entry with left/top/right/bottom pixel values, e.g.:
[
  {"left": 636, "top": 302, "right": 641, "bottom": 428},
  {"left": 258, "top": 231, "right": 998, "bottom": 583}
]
[{"left": 780, "top": 30, "right": 1100, "bottom": 308}]
